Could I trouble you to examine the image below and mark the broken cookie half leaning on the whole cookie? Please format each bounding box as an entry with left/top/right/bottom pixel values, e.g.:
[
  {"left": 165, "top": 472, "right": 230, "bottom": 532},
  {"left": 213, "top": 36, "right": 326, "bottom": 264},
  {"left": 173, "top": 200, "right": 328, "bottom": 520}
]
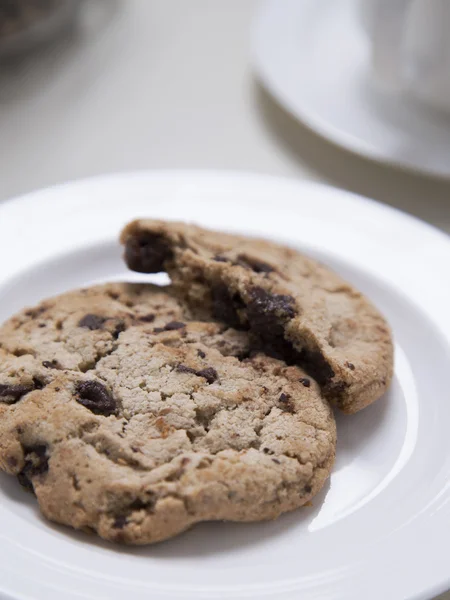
[{"left": 121, "top": 220, "right": 393, "bottom": 413}]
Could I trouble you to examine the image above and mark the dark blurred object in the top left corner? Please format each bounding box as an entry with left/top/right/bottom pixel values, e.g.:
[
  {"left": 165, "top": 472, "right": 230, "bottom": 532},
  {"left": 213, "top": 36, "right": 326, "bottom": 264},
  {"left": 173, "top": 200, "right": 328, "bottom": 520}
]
[{"left": 0, "top": 0, "right": 81, "bottom": 58}]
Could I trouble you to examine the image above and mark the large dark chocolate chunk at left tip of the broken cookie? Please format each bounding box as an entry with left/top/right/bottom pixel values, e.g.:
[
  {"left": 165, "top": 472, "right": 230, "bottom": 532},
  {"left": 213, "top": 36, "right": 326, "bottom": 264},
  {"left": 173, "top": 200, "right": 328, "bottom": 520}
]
[{"left": 125, "top": 231, "right": 173, "bottom": 273}]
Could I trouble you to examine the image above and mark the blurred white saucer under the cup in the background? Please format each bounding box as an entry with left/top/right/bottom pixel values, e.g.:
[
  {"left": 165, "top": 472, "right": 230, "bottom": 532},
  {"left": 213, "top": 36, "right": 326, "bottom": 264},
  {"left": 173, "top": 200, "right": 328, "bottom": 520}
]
[{"left": 252, "top": 0, "right": 450, "bottom": 177}]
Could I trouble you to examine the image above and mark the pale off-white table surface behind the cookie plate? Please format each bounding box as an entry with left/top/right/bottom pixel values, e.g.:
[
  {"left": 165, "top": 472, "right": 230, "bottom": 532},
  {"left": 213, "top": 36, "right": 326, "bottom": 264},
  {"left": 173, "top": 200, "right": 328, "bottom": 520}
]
[{"left": 0, "top": 0, "right": 450, "bottom": 600}]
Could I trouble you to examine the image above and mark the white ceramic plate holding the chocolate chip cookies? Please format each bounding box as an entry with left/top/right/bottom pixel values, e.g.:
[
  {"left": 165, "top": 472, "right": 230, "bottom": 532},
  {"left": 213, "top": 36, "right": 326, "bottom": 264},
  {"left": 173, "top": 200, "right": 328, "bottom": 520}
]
[{"left": 0, "top": 171, "right": 450, "bottom": 600}]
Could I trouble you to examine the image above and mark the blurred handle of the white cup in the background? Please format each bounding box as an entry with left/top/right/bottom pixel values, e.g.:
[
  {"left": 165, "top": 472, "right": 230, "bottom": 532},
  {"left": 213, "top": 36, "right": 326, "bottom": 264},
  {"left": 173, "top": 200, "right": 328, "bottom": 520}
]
[{"left": 372, "top": 0, "right": 416, "bottom": 91}]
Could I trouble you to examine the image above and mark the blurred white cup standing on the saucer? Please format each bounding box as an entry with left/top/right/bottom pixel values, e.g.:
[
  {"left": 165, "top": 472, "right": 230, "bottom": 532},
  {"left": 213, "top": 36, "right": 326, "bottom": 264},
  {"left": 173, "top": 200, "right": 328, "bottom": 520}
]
[{"left": 359, "top": 0, "right": 450, "bottom": 111}]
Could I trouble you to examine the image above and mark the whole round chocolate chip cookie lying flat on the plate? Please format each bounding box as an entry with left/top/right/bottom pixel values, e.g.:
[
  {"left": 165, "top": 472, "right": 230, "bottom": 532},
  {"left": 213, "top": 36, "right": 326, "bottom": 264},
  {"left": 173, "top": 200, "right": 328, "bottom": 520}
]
[{"left": 0, "top": 284, "right": 336, "bottom": 544}]
